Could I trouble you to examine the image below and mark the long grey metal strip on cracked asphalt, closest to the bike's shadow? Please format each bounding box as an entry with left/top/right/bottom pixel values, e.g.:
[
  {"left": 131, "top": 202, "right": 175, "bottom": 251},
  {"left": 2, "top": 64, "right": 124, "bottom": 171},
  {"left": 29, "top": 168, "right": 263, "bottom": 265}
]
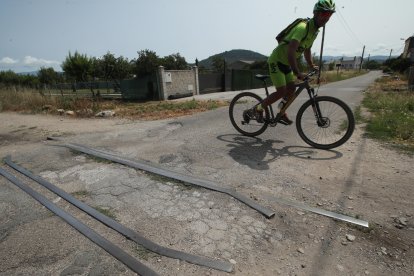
[{"left": 57, "top": 141, "right": 275, "bottom": 218}]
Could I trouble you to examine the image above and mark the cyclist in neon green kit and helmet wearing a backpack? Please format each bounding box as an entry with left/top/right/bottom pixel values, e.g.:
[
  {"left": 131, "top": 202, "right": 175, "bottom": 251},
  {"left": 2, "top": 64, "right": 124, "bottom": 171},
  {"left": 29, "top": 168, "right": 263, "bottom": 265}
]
[{"left": 253, "top": 0, "right": 335, "bottom": 125}]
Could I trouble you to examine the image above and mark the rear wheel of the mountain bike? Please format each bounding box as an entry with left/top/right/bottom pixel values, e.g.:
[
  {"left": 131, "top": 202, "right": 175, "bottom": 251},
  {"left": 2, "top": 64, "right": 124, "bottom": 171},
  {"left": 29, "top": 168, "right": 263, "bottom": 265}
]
[{"left": 229, "top": 92, "right": 269, "bottom": 137}]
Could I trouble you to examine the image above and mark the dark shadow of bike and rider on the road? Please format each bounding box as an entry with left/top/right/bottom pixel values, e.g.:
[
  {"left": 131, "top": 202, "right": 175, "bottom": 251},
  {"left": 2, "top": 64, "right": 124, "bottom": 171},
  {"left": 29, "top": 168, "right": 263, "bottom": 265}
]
[{"left": 217, "top": 134, "right": 343, "bottom": 170}]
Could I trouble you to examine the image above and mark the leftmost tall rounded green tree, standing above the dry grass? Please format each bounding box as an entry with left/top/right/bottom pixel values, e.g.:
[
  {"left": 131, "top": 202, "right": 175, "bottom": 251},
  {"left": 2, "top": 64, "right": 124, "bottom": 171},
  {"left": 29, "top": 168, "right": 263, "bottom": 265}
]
[{"left": 62, "top": 51, "right": 94, "bottom": 82}]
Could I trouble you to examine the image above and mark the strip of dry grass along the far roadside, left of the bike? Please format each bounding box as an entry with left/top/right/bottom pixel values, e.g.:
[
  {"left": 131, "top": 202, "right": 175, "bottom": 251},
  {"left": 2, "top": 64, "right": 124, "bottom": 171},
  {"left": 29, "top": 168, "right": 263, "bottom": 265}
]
[{"left": 0, "top": 89, "right": 228, "bottom": 120}]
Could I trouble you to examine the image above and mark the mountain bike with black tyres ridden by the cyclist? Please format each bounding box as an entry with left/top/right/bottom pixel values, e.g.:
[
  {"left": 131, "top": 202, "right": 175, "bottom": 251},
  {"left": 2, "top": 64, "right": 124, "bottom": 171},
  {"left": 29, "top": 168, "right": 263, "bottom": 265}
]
[{"left": 229, "top": 71, "right": 355, "bottom": 149}]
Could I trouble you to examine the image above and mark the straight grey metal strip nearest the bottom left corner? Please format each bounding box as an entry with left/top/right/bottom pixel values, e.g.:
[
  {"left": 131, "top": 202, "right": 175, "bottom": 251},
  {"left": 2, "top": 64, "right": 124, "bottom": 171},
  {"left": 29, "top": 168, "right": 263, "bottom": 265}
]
[{"left": 0, "top": 168, "right": 158, "bottom": 276}]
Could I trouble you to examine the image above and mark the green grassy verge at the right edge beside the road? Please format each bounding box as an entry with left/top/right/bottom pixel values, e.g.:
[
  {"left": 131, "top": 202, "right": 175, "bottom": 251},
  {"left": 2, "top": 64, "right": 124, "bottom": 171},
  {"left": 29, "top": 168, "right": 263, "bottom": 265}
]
[{"left": 362, "top": 75, "right": 414, "bottom": 154}]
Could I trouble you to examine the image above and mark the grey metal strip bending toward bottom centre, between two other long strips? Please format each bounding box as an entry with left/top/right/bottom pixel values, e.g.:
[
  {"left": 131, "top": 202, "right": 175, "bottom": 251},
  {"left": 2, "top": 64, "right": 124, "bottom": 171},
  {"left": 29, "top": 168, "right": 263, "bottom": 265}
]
[{"left": 5, "top": 155, "right": 233, "bottom": 272}]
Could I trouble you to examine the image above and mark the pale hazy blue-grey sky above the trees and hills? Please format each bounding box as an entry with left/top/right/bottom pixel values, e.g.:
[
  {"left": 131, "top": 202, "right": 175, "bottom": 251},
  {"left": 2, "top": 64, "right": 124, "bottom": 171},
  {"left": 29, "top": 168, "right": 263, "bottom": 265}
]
[{"left": 0, "top": 0, "right": 414, "bottom": 72}]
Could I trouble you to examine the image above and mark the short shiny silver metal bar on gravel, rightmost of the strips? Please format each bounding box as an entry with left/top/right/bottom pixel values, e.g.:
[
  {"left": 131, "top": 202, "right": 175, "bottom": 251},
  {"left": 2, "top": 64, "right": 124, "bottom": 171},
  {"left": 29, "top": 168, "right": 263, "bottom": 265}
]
[{"left": 265, "top": 193, "right": 369, "bottom": 228}]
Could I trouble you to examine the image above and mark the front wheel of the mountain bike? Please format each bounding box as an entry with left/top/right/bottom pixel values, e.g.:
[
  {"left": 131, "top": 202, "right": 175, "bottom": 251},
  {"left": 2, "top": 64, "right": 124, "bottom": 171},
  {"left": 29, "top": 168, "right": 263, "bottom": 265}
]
[{"left": 296, "top": 96, "right": 355, "bottom": 149}]
